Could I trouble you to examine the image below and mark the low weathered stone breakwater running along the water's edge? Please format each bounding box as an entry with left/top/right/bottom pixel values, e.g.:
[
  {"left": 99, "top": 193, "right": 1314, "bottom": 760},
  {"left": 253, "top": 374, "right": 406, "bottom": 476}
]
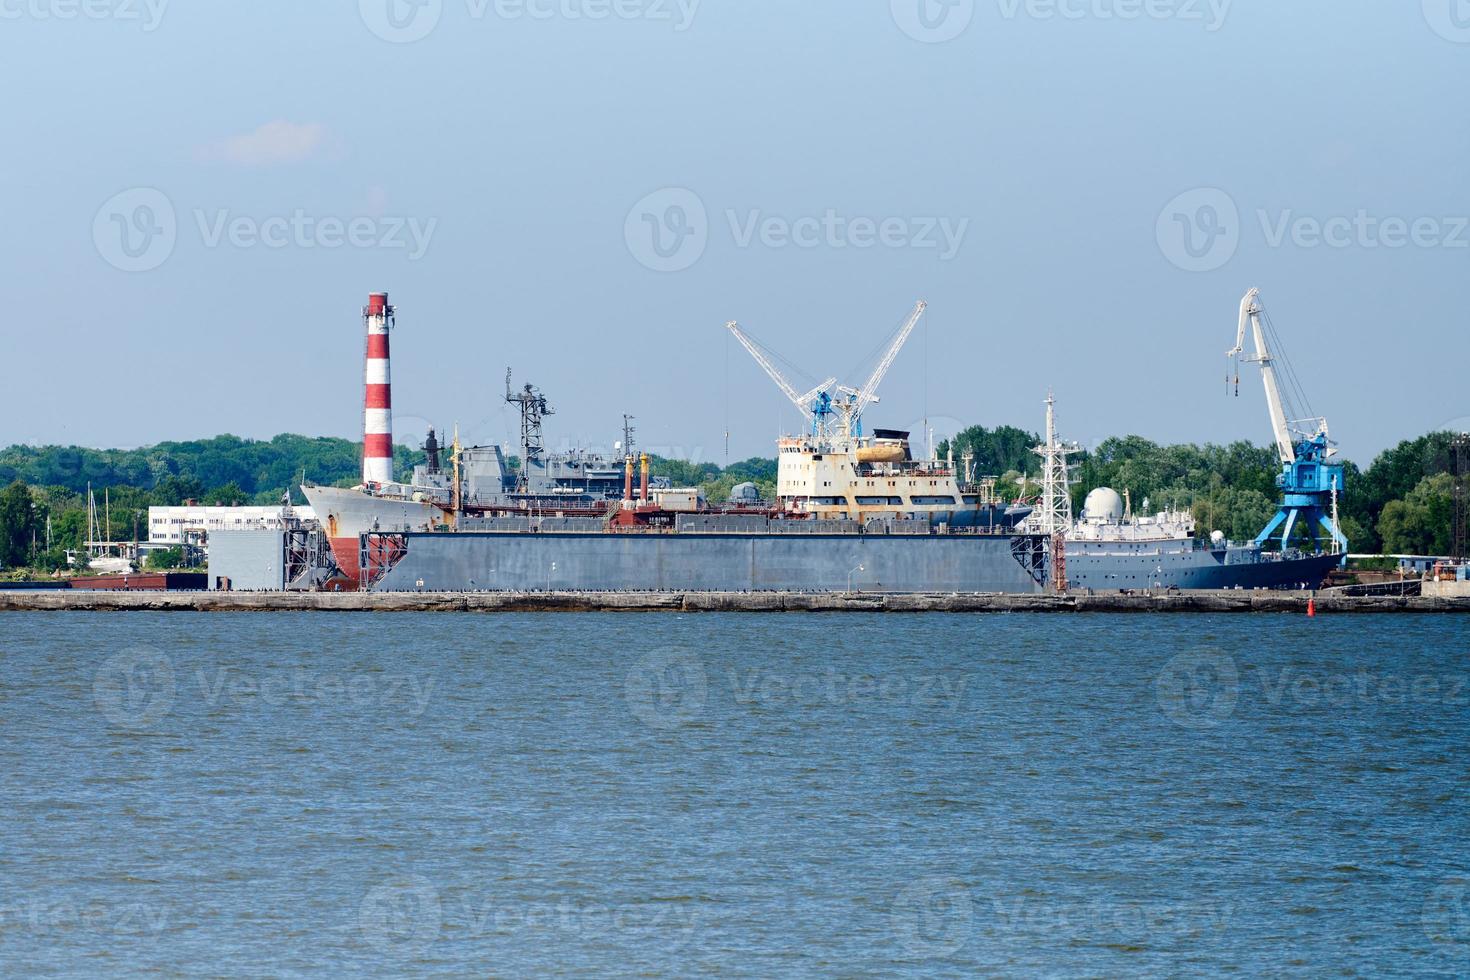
[{"left": 0, "top": 591, "right": 1470, "bottom": 616}]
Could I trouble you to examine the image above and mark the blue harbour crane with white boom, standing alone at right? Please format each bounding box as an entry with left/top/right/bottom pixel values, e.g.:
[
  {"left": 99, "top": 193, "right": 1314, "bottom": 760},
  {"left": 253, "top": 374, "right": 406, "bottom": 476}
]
[{"left": 1226, "top": 289, "right": 1348, "bottom": 561}]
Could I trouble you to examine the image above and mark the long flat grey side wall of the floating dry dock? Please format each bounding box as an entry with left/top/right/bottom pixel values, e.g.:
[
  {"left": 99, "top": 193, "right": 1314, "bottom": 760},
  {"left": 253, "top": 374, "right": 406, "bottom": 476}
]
[{"left": 363, "top": 532, "right": 1047, "bottom": 592}]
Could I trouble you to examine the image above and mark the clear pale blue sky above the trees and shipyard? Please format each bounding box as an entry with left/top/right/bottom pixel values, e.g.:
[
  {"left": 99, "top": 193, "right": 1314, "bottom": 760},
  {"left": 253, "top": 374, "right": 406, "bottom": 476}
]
[{"left": 0, "top": 0, "right": 1470, "bottom": 463}]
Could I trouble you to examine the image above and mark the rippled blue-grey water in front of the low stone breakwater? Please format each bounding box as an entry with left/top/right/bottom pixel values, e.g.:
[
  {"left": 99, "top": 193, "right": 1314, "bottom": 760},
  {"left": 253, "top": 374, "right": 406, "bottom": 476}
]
[{"left": 0, "top": 614, "right": 1470, "bottom": 977}]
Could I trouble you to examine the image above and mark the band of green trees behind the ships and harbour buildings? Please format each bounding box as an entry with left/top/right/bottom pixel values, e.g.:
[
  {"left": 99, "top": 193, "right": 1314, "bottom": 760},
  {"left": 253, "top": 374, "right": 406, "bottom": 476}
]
[{"left": 0, "top": 426, "right": 1455, "bottom": 567}]
